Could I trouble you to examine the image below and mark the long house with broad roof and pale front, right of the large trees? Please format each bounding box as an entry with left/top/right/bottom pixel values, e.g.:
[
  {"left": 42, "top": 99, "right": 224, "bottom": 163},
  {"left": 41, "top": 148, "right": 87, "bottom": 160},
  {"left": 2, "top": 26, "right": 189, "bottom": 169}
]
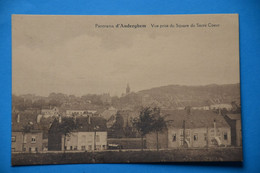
[{"left": 146, "top": 110, "right": 231, "bottom": 148}]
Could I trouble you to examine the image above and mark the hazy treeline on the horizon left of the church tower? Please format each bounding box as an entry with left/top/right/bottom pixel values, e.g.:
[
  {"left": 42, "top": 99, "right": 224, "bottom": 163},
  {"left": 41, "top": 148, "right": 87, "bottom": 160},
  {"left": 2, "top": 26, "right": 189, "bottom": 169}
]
[{"left": 12, "top": 93, "right": 119, "bottom": 111}]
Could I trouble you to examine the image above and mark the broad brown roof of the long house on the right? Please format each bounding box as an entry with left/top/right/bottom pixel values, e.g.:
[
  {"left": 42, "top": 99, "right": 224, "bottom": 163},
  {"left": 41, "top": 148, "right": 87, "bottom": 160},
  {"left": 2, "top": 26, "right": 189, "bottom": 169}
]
[{"left": 161, "top": 110, "right": 230, "bottom": 128}]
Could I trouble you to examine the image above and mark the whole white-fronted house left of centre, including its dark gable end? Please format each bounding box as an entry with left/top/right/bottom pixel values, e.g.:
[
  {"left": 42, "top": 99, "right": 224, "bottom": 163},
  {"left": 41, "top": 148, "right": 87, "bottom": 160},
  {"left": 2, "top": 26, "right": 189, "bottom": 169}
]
[{"left": 48, "top": 116, "right": 107, "bottom": 151}]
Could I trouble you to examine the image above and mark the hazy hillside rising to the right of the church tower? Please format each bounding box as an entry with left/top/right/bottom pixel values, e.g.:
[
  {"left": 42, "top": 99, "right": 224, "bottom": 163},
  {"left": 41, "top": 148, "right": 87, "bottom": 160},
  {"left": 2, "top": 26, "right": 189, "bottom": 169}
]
[{"left": 120, "top": 84, "right": 240, "bottom": 108}]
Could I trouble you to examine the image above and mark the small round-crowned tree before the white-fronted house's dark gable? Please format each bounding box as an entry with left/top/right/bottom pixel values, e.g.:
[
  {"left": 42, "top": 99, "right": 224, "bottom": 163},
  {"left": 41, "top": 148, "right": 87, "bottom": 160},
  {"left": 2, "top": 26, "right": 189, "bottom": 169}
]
[{"left": 59, "top": 117, "right": 76, "bottom": 152}]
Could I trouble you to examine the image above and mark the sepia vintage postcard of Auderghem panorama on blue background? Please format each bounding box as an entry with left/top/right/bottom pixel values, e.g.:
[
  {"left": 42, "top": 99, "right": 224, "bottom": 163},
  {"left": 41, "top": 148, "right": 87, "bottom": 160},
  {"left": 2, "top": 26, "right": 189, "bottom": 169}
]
[{"left": 10, "top": 14, "right": 243, "bottom": 165}]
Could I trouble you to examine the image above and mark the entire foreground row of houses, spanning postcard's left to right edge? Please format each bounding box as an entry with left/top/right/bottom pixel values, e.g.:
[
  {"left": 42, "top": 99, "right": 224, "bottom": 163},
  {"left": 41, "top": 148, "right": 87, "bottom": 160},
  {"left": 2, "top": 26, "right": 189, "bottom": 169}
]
[{"left": 12, "top": 109, "right": 242, "bottom": 152}]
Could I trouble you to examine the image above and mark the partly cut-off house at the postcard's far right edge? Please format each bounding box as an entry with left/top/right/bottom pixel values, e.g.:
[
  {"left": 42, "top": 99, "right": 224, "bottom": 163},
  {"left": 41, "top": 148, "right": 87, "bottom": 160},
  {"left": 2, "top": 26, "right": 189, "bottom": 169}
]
[{"left": 224, "top": 113, "right": 242, "bottom": 147}]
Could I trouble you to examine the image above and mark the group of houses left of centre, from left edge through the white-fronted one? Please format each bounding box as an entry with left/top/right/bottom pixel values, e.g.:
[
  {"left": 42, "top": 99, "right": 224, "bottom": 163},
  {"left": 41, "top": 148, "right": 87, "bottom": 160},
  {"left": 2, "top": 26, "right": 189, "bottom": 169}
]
[{"left": 12, "top": 114, "right": 107, "bottom": 152}]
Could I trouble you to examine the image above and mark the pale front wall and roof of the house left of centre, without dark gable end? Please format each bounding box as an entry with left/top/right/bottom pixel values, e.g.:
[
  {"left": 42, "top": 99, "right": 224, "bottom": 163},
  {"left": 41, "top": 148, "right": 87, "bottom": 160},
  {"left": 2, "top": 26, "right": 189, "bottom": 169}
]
[{"left": 62, "top": 116, "right": 107, "bottom": 151}]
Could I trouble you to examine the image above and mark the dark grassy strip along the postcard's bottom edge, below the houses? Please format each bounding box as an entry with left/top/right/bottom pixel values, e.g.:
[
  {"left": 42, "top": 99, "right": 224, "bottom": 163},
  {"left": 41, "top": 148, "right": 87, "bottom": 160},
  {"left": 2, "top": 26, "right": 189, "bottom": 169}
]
[{"left": 12, "top": 148, "right": 242, "bottom": 166}]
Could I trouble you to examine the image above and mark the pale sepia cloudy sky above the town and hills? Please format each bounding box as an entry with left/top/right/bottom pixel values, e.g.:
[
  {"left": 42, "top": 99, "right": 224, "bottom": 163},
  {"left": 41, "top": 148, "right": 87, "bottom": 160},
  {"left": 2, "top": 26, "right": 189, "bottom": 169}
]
[{"left": 12, "top": 15, "right": 239, "bottom": 96}]
